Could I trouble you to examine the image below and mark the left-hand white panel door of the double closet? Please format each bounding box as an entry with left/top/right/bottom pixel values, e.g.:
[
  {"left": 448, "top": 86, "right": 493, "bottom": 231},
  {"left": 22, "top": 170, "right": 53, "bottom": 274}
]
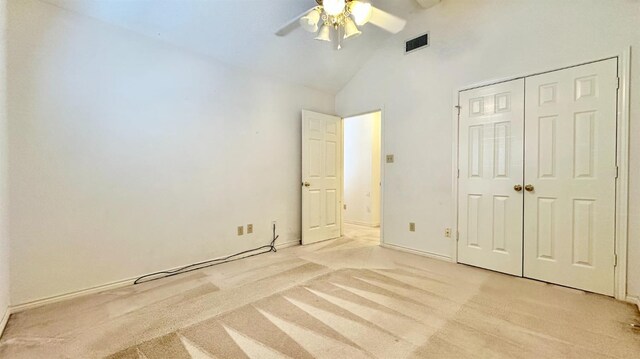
[{"left": 458, "top": 79, "right": 524, "bottom": 276}]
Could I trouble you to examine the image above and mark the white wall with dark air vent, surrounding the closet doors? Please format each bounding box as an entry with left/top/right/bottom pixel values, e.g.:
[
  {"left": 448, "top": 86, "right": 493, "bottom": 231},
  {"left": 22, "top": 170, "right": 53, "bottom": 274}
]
[{"left": 336, "top": 0, "right": 640, "bottom": 296}]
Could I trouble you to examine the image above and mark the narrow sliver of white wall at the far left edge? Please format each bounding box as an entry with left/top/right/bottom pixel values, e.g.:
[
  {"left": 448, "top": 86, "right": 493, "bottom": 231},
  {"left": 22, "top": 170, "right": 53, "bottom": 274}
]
[{"left": 0, "top": 0, "right": 10, "bottom": 335}]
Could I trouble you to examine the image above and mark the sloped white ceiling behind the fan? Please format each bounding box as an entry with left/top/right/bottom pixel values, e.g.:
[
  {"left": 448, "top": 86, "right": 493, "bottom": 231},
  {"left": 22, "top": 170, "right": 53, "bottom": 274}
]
[{"left": 44, "top": 0, "right": 419, "bottom": 93}]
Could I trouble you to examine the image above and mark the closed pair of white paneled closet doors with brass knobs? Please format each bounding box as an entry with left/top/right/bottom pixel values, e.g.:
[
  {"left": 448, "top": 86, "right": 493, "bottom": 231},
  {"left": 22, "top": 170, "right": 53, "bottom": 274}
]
[{"left": 458, "top": 59, "right": 618, "bottom": 295}]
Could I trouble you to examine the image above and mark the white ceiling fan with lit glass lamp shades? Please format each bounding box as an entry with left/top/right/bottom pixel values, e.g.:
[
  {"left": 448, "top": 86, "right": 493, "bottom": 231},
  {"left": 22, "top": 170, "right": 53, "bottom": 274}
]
[{"left": 276, "top": 0, "right": 407, "bottom": 50}]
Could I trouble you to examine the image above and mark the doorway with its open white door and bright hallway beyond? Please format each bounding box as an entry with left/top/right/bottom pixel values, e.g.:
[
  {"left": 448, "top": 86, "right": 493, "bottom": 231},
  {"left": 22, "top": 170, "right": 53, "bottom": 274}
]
[{"left": 301, "top": 110, "right": 384, "bottom": 245}]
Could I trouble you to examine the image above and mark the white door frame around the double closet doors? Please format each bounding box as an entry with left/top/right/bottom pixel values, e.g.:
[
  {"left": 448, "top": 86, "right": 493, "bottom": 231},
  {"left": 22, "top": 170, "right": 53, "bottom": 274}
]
[{"left": 451, "top": 46, "right": 635, "bottom": 303}]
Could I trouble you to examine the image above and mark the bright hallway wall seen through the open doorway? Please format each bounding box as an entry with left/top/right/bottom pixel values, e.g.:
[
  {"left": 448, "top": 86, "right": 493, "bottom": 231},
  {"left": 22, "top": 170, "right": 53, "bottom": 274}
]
[{"left": 343, "top": 112, "right": 380, "bottom": 226}]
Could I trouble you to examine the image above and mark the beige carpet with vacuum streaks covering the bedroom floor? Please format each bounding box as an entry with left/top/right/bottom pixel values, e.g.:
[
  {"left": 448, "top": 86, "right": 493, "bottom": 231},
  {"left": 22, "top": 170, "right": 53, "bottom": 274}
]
[{"left": 0, "top": 226, "right": 640, "bottom": 359}]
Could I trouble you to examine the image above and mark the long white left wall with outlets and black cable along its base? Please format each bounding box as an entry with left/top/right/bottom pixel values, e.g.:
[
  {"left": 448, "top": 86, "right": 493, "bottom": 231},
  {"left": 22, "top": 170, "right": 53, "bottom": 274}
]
[{"left": 8, "top": 0, "right": 335, "bottom": 305}]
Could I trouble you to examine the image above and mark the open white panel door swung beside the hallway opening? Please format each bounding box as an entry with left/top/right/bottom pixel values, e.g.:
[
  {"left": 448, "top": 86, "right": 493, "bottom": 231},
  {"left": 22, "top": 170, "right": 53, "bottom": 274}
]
[{"left": 302, "top": 110, "right": 342, "bottom": 244}]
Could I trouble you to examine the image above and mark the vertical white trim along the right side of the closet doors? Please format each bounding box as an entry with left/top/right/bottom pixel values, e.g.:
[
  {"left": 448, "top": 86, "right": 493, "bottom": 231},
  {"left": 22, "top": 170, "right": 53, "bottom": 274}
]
[{"left": 614, "top": 47, "right": 631, "bottom": 300}]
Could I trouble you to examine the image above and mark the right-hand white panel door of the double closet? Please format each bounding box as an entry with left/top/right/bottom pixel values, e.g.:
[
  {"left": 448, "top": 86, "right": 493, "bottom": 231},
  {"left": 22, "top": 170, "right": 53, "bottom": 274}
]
[{"left": 524, "top": 59, "right": 617, "bottom": 295}]
